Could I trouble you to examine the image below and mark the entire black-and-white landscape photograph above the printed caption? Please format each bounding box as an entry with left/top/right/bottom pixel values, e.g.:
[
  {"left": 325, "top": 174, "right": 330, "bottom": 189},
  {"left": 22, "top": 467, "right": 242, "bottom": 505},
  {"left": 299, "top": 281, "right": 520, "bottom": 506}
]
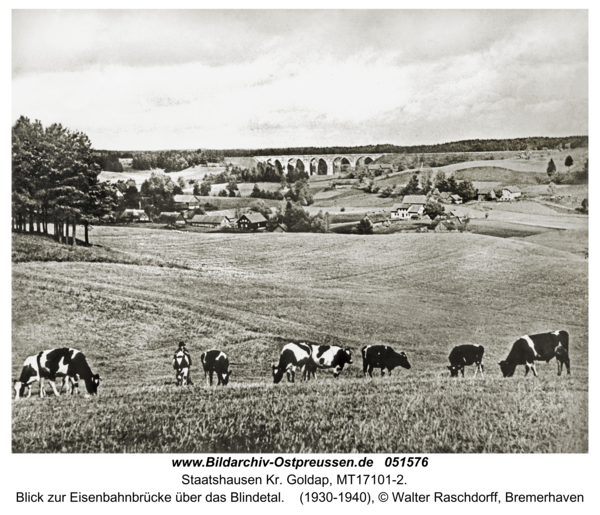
[{"left": 11, "top": 9, "right": 590, "bottom": 460}]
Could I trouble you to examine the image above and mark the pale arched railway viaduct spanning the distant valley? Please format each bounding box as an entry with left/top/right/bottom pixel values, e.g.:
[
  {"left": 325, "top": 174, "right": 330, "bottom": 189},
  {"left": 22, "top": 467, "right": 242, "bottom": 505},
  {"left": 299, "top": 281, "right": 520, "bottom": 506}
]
[{"left": 253, "top": 154, "right": 385, "bottom": 175}]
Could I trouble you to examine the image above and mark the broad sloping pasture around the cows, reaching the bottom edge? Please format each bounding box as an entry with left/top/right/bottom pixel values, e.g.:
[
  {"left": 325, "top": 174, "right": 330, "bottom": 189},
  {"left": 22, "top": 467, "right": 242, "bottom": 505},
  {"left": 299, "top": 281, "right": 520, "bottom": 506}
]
[{"left": 12, "top": 227, "right": 588, "bottom": 452}]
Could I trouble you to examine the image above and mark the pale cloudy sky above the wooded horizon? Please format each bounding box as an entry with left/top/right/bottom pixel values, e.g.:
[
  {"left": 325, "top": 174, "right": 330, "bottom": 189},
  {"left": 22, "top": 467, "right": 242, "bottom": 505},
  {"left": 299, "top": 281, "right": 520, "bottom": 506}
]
[{"left": 12, "top": 10, "right": 588, "bottom": 150}]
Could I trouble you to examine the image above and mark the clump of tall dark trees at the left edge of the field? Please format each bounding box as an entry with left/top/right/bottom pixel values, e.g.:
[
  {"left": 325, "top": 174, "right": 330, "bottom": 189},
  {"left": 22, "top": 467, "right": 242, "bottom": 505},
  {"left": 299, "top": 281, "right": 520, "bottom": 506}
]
[{"left": 12, "top": 116, "right": 117, "bottom": 245}]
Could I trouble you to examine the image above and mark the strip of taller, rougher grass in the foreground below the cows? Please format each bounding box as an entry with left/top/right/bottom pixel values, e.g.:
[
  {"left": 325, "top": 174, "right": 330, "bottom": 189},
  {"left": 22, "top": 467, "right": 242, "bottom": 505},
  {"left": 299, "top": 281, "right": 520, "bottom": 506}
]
[{"left": 12, "top": 370, "right": 587, "bottom": 453}]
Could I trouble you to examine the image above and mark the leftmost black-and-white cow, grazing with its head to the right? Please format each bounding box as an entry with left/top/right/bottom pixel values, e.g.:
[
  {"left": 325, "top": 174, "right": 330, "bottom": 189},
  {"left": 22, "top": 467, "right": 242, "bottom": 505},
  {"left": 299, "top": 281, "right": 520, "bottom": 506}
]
[{"left": 15, "top": 348, "right": 100, "bottom": 399}]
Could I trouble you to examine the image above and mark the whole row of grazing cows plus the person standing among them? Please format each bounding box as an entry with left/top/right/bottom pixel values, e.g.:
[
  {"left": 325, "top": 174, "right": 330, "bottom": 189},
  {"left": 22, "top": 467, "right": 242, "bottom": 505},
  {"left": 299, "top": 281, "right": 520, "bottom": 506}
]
[{"left": 14, "top": 331, "right": 571, "bottom": 399}]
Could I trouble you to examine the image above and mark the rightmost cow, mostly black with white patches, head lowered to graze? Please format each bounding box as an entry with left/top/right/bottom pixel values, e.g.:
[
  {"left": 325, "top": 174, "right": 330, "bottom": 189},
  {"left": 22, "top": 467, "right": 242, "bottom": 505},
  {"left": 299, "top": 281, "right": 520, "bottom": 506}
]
[{"left": 498, "top": 331, "right": 571, "bottom": 377}]
